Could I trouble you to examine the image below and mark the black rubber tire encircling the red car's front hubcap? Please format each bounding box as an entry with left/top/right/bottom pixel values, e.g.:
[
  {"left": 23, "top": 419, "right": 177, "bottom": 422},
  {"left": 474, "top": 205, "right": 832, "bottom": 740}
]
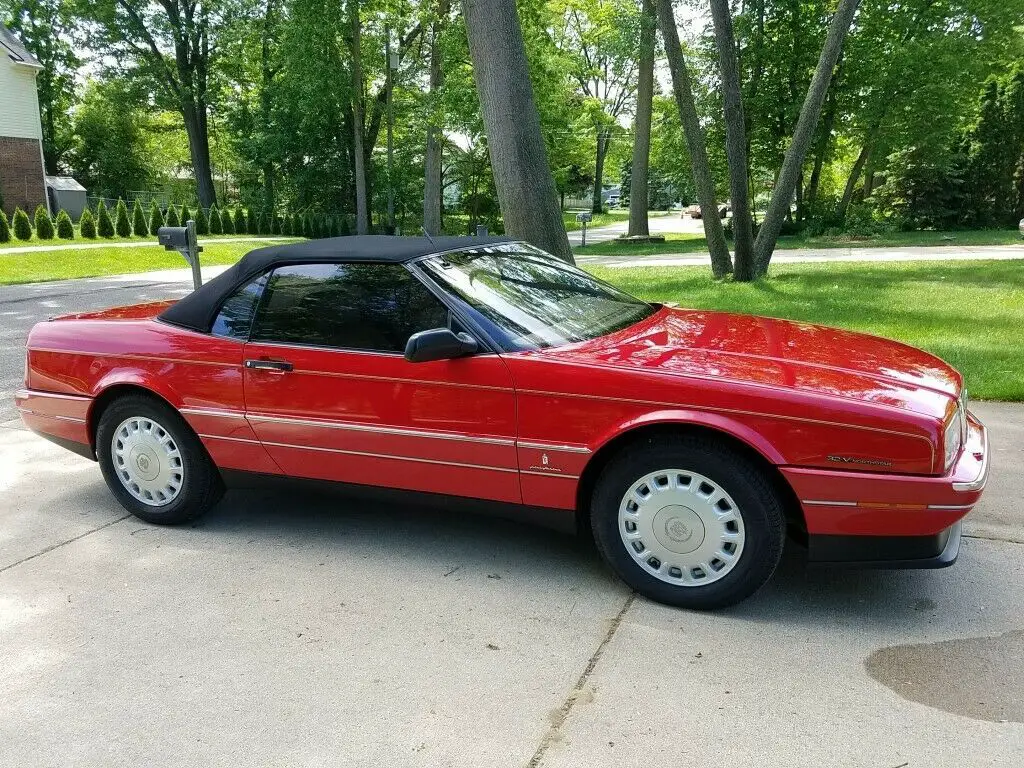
[{"left": 591, "top": 434, "right": 785, "bottom": 609}]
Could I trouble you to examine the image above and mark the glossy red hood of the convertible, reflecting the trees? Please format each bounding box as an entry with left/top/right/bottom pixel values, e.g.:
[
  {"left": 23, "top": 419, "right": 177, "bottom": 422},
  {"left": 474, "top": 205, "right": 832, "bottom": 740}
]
[{"left": 550, "top": 307, "right": 962, "bottom": 418}]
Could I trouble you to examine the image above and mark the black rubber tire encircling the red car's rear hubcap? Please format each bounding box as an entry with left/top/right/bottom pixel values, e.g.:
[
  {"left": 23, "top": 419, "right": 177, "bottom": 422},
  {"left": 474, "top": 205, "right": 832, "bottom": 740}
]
[{"left": 96, "top": 394, "right": 224, "bottom": 525}]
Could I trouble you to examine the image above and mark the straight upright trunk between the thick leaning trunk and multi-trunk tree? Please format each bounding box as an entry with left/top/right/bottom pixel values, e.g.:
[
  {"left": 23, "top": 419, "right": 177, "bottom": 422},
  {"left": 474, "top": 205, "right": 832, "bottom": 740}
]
[{"left": 627, "top": 0, "right": 655, "bottom": 238}]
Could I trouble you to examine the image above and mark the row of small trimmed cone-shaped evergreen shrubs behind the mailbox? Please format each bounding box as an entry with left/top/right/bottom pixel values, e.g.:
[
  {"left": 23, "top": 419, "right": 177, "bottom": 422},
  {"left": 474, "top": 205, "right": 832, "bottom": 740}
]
[{"left": 0, "top": 200, "right": 351, "bottom": 243}]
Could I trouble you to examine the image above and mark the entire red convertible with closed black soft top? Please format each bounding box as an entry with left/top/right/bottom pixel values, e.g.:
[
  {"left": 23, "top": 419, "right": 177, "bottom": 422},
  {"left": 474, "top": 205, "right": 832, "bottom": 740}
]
[{"left": 16, "top": 237, "right": 988, "bottom": 608}]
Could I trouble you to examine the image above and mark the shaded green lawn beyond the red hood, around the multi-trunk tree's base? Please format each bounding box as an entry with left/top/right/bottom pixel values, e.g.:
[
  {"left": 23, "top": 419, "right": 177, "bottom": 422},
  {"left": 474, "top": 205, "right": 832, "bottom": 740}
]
[{"left": 590, "top": 261, "right": 1024, "bottom": 400}]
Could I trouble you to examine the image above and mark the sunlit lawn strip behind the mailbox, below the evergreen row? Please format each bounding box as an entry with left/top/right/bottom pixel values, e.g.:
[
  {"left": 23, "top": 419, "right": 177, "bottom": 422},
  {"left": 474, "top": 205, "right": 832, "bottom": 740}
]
[{"left": 0, "top": 241, "right": 299, "bottom": 285}]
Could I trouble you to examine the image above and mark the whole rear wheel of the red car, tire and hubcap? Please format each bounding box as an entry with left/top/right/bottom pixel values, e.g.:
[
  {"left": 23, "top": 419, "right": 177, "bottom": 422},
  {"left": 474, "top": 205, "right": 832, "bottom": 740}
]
[{"left": 96, "top": 394, "right": 223, "bottom": 524}]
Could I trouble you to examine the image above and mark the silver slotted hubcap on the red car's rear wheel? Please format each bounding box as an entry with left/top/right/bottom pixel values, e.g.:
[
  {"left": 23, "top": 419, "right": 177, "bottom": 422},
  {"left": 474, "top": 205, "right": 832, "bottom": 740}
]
[{"left": 111, "top": 417, "right": 184, "bottom": 507}]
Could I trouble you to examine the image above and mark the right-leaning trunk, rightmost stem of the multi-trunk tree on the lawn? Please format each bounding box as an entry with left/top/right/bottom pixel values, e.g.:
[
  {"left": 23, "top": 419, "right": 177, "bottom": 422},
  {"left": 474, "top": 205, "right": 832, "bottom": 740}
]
[{"left": 754, "top": 0, "right": 860, "bottom": 274}]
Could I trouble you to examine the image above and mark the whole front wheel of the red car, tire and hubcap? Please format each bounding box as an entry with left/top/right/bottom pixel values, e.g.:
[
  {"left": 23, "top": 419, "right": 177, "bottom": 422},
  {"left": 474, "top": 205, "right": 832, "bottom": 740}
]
[{"left": 591, "top": 435, "right": 785, "bottom": 608}]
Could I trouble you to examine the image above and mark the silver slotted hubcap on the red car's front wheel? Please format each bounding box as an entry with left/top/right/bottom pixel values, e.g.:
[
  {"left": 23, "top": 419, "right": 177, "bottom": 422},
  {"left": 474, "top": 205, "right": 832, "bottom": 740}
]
[{"left": 618, "top": 469, "right": 745, "bottom": 587}]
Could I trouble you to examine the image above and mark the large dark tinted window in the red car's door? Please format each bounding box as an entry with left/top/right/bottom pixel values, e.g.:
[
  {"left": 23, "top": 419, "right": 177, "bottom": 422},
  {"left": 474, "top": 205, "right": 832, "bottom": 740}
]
[{"left": 251, "top": 264, "right": 449, "bottom": 352}]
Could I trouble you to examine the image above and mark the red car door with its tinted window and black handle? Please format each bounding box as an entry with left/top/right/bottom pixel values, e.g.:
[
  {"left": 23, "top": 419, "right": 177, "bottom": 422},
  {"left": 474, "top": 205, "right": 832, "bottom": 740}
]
[{"left": 244, "top": 262, "right": 521, "bottom": 502}]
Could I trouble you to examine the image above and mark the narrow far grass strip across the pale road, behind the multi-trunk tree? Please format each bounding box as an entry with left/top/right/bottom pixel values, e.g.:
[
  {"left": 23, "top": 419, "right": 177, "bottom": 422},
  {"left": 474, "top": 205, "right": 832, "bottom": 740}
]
[{"left": 575, "top": 229, "right": 1024, "bottom": 256}]
